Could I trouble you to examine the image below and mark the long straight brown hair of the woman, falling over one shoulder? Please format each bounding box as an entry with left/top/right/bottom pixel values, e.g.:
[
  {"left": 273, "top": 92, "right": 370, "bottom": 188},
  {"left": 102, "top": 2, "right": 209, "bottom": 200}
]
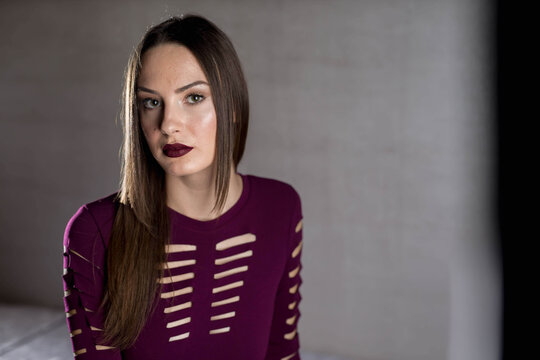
[{"left": 101, "top": 15, "right": 249, "bottom": 349}]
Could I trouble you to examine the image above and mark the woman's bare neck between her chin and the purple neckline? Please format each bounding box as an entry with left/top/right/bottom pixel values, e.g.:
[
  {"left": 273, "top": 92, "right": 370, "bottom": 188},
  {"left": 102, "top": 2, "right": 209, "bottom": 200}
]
[{"left": 165, "top": 167, "right": 242, "bottom": 221}]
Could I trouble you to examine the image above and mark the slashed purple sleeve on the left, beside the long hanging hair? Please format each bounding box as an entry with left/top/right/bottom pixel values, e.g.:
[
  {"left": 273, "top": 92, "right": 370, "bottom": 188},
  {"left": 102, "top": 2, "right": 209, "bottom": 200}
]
[{"left": 62, "top": 206, "right": 122, "bottom": 360}]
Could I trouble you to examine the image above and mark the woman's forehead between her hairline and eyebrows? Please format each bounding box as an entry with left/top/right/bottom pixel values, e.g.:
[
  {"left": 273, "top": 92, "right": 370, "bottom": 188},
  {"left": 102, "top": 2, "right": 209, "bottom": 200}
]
[{"left": 138, "top": 43, "right": 207, "bottom": 86}]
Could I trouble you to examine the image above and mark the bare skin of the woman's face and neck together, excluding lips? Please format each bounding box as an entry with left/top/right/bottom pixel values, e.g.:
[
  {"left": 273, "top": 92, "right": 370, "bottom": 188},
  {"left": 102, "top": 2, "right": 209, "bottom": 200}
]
[{"left": 137, "top": 43, "right": 242, "bottom": 221}]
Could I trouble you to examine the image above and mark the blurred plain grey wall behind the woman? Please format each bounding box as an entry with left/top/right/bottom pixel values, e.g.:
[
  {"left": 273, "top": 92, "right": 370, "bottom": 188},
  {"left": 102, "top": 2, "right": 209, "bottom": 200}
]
[{"left": 0, "top": 0, "right": 500, "bottom": 360}]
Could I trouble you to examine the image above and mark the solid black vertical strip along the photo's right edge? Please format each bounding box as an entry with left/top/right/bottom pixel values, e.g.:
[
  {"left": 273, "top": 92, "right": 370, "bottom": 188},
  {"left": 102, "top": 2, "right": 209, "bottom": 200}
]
[{"left": 494, "top": 0, "right": 540, "bottom": 360}]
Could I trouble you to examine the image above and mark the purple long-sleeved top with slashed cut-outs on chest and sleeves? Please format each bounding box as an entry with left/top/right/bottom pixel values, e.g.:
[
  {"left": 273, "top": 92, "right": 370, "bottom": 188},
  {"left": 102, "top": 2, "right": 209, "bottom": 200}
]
[{"left": 63, "top": 174, "right": 303, "bottom": 360}]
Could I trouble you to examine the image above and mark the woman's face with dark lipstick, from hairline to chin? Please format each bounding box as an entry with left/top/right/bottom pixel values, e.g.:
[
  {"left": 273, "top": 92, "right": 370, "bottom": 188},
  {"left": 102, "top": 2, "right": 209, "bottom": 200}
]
[{"left": 137, "top": 43, "right": 217, "bottom": 180}]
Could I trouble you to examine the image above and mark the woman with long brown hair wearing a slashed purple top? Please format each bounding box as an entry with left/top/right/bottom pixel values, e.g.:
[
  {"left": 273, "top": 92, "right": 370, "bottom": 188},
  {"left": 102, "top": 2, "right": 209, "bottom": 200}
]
[{"left": 63, "top": 16, "right": 302, "bottom": 360}]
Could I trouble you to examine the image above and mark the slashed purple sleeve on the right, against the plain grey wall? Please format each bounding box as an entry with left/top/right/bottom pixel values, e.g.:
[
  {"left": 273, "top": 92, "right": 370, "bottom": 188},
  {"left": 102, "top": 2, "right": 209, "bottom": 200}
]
[{"left": 265, "top": 192, "right": 303, "bottom": 360}]
